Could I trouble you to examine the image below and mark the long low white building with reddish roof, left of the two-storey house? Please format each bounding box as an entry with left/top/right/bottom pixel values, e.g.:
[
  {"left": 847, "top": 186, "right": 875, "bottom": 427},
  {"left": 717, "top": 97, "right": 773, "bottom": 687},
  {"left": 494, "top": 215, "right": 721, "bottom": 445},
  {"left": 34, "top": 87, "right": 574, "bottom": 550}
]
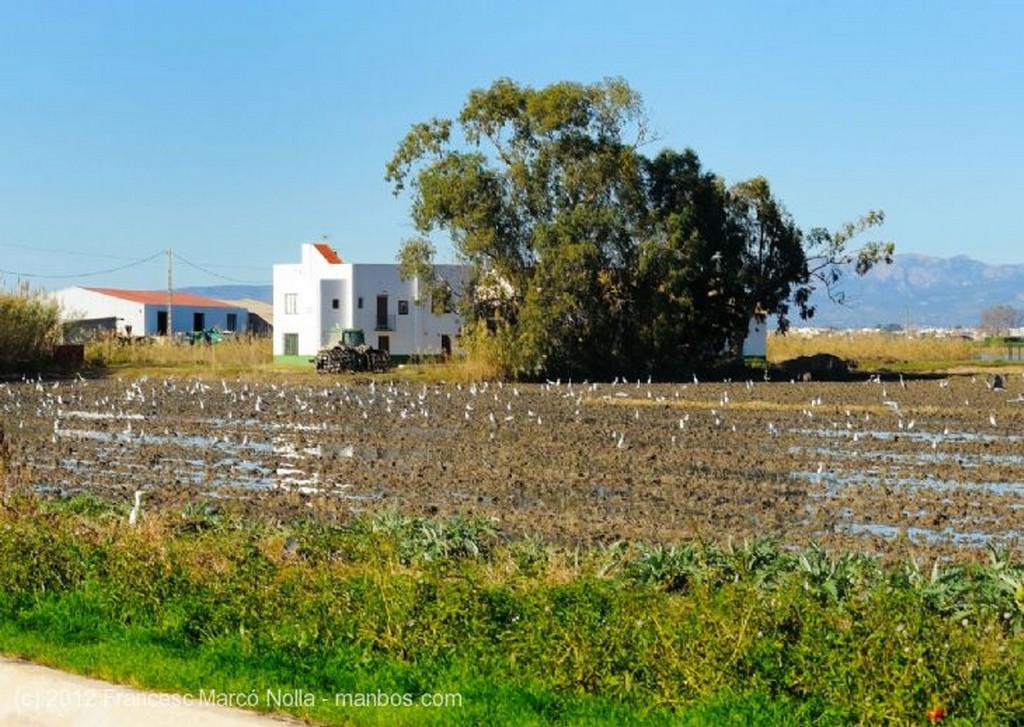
[{"left": 52, "top": 288, "right": 249, "bottom": 337}]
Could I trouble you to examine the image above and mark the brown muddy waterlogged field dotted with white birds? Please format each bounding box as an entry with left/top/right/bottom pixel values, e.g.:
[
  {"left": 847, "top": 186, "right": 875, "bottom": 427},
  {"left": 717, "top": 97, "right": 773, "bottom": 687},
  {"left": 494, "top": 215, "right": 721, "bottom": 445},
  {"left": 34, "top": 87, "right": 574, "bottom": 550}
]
[{"left": 0, "top": 374, "right": 1024, "bottom": 558}]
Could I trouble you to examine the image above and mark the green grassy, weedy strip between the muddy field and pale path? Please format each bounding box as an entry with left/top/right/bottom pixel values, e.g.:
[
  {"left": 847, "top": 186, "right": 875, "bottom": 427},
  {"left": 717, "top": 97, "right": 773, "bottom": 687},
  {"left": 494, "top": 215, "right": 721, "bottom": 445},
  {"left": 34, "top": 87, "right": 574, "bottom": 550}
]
[{"left": 0, "top": 493, "right": 1024, "bottom": 725}]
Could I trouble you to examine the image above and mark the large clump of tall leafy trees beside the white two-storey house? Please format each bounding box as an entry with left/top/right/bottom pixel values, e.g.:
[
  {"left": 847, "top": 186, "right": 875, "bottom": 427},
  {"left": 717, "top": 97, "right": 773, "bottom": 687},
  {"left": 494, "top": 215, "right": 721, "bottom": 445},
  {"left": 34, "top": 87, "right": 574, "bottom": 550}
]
[{"left": 386, "top": 79, "right": 892, "bottom": 377}]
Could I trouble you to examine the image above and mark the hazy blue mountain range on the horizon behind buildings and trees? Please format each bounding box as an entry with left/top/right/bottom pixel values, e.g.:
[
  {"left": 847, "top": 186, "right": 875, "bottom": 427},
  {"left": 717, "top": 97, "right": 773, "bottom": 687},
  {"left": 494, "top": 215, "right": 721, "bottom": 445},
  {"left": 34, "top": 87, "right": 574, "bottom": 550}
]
[{"left": 181, "top": 254, "right": 1024, "bottom": 329}]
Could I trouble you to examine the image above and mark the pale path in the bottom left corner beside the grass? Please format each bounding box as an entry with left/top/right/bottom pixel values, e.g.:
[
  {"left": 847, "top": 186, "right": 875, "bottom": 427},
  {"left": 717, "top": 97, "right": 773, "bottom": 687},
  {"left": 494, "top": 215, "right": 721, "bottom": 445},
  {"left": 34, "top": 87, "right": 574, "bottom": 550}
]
[{"left": 0, "top": 657, "right": 299, "bottom": 727}]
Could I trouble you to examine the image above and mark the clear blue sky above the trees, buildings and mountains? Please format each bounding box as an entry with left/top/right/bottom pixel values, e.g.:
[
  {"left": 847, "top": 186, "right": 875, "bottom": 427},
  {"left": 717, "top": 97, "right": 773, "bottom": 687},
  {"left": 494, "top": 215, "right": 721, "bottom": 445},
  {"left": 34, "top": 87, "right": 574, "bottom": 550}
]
[{"left": 0, "top": 0, "right": 1024, "bottom": 289}]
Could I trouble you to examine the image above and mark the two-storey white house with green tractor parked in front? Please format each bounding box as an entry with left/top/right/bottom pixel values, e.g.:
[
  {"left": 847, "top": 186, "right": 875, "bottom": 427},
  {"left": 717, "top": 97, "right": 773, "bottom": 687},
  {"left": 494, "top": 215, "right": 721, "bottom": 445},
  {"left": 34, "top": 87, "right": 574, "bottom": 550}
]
[{"left": 273, "top": 243, "right": 463, "bottom": 356}]
